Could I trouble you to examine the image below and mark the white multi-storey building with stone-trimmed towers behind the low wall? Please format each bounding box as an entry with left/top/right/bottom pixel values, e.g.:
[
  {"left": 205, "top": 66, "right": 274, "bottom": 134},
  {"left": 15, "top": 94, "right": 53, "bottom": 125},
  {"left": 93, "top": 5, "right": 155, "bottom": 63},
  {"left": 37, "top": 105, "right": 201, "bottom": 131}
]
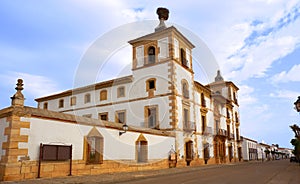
[{"left": 36, "top": 27, "right": 241, "bottom": 164}]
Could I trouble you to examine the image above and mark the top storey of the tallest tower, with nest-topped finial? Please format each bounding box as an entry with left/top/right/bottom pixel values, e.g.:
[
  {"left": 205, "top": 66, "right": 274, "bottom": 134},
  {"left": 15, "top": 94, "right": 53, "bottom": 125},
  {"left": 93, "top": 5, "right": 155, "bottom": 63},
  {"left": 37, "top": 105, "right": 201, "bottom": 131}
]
[{"left": 129, "top": 8, "right": 194, "bottom": 72}]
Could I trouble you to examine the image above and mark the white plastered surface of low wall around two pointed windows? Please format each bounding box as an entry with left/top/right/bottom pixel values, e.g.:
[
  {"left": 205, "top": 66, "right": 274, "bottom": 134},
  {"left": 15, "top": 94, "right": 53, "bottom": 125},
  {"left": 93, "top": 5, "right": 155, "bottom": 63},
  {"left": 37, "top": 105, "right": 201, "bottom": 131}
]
[{"left": 22, "top": 118, "right": 175, "bottom": 160}]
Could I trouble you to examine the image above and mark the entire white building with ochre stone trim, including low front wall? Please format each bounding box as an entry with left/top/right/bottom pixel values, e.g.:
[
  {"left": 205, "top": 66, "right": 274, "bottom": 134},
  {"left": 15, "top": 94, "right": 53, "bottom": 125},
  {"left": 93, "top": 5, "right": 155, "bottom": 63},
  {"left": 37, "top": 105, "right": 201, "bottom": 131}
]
[{"left": 0, "top": 8, "right": 243, "bottom": 180}]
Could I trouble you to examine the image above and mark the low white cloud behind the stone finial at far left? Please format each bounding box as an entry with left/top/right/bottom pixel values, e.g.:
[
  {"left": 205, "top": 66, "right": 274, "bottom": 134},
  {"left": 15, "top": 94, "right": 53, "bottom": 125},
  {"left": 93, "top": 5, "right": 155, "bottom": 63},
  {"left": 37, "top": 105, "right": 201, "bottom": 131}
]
[{"left": 0, "top": 72, "right": 58, "bottom": 98}]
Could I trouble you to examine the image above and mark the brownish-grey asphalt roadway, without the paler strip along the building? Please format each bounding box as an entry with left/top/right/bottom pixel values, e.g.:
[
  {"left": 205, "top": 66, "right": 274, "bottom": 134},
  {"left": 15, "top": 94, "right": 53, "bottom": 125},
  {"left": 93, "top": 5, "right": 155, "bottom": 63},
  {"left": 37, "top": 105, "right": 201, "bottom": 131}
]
[{"left": 118, "top": 160, "right": 300, "bottom": 184}]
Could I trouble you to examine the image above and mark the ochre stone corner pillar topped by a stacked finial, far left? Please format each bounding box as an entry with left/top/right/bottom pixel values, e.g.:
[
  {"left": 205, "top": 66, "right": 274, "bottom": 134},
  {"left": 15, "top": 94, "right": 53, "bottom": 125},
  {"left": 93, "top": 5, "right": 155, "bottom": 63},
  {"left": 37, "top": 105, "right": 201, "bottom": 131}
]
[{"left": 0, "top": 79, "right": 30, "bottom": 181}]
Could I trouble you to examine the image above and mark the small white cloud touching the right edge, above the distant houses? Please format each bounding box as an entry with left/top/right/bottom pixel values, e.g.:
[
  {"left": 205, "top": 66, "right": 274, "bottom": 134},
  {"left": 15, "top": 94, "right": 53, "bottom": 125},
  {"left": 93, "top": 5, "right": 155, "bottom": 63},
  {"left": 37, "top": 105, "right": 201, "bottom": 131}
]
[{"left": 271, "top": 64, "right": 300, "bottom": 83}]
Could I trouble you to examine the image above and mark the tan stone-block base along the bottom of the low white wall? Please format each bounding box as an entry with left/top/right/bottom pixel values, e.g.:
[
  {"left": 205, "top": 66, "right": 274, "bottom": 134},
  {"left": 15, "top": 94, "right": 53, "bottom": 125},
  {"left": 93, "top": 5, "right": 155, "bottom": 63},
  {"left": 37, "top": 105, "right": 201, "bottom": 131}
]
[{"left": 0, "top": 160, "right": 169, "bottom": 181}]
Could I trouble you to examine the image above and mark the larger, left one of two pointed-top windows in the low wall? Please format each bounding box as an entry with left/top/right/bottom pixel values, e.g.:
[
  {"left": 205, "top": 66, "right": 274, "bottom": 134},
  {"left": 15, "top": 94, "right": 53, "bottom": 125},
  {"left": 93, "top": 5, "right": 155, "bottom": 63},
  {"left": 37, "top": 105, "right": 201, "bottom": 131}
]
[{"left": 84, "top": 128, "right": 104, "bottom": 164}]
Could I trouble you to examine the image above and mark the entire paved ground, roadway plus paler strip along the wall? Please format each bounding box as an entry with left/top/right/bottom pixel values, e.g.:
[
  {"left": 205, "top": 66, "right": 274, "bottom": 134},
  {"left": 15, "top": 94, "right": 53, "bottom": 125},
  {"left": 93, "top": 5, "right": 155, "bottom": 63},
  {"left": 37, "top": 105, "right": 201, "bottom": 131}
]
[{"left": 3, "top": 160, "right": 300, "bottom": 184}]
